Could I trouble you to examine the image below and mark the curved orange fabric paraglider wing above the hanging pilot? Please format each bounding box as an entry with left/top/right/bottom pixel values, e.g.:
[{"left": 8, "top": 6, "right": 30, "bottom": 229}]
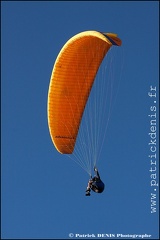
[{"left": 48, "top": 31, "right": 121, "bottom": 154}]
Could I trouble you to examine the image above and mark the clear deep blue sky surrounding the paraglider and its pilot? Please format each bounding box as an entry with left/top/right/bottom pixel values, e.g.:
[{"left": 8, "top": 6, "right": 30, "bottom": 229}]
[{"left": 1, "top": 1, "right": 159, "bottom": 239}]
